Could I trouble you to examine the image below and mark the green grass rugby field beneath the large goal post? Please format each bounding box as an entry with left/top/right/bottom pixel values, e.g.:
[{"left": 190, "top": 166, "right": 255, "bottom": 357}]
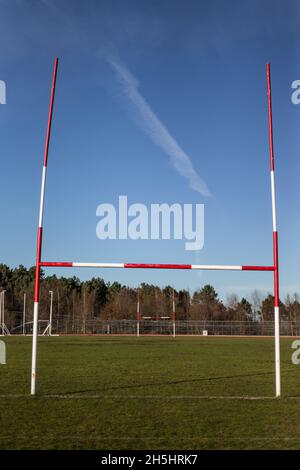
[{"left": 0, "top": 336, "right": 300, "bottom": 450}]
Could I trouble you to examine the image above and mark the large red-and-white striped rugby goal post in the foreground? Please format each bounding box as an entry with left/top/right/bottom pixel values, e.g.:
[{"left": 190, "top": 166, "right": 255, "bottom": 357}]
[{"left": 31, "top": 58, "right": 281, "bottom": 397}]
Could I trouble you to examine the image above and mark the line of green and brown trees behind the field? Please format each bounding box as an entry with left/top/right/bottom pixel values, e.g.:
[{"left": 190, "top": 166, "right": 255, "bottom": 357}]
[{"left": 0, "top": 264, "right": 300, "bottom": 327}]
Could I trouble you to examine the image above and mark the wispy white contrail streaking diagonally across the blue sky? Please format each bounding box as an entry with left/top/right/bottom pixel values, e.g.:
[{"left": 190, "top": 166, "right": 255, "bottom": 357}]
[{"left": 107, "top": 57, "right": 210, "bottom": 196}]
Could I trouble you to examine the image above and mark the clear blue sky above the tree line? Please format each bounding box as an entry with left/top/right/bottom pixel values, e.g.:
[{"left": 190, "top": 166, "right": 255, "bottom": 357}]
[{"left": 0, "top": 0, "right": 300, "bottom": 298}]
